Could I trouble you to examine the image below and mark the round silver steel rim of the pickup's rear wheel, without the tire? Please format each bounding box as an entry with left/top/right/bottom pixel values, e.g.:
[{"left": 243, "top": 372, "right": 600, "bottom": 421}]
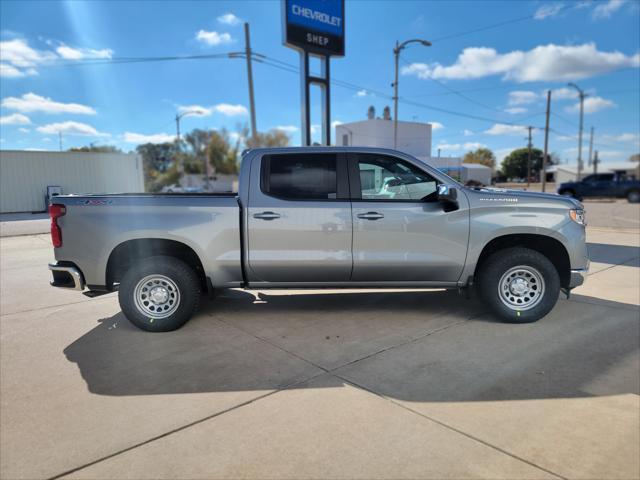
[{"left": 133, "top": 275, "right": 180, "bottom": 319}]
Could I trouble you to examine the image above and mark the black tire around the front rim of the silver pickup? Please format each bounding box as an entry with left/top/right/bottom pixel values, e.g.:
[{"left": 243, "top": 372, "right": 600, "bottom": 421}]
[{"left": 478, "top": 247, "right": 560, "bottom": 323}]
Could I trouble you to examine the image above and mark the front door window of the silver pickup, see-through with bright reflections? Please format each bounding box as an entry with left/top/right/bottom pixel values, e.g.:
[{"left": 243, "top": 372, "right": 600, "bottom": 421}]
[{"left": 358, "top": 155, "right": 437, "bottom": 201}]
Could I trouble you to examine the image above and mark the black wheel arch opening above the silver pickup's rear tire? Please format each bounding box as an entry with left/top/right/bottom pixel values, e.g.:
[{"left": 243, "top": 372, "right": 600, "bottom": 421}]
[{"left": 105, "top": 238, "right": 208, "bottom": 291}]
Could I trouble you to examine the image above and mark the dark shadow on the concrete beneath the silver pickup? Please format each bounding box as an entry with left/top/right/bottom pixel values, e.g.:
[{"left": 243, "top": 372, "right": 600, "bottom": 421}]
[{"left": 64, "top": 291, "right": 640, "bottom": 402}]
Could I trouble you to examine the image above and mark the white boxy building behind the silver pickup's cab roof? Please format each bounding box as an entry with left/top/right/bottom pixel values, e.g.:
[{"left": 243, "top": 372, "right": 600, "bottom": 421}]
[{"left": 336, "top": 118, "right": 431, "bottom": 157}]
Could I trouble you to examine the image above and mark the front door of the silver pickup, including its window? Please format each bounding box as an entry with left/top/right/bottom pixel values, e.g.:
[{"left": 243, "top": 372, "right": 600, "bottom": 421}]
[{"left": 349, "top": 153, "right": 469, "bottom": 282}]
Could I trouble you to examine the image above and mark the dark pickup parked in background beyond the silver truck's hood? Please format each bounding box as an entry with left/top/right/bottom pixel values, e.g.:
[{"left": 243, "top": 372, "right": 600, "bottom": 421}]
[{"left": 558, "top": 173, "right": 640, "bottom": 203}]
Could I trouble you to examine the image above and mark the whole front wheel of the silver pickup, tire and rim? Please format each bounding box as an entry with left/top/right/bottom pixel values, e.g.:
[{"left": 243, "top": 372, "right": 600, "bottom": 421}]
[{"left": 479, "top": 247, "right": 560, "bottom": 323}]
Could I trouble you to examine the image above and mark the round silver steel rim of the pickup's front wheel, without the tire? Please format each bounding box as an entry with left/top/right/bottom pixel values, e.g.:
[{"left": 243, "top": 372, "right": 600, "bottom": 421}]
[{"left": 498, "top": 265, "right": 544, "bottom": 310}]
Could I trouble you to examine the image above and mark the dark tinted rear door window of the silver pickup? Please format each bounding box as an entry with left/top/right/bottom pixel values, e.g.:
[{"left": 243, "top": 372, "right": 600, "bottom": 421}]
[{"left": 262, "top": 154, "right": 338, "bottom": 200}]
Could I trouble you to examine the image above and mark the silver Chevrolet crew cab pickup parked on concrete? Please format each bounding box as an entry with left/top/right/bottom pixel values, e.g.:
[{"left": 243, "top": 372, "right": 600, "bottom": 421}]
[{"left": 49, "top": 147, "right": 589, "bottom": 331}]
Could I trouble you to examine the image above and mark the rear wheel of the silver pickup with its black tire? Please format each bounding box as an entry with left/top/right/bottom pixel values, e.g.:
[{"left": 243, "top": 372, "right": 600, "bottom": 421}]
[{"left": 118, "top": 256, "right": 200, "bottom": 332}]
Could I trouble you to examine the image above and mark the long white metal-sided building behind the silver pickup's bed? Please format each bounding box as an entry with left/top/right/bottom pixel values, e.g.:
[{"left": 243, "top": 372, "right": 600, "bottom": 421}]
[{"left": 0, "top": 150, "right": 144, "bottom": 213}]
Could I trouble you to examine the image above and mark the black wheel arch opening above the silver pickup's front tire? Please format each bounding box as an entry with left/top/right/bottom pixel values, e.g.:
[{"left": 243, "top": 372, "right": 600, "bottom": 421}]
[{"left": 473, "top": 233, "right": 571, "bottom": 287}]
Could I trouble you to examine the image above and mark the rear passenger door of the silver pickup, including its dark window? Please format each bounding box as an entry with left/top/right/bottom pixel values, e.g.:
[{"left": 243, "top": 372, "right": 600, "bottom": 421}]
[{"left": 247, "top": 153, "right": 352, "bottom": 283}]
